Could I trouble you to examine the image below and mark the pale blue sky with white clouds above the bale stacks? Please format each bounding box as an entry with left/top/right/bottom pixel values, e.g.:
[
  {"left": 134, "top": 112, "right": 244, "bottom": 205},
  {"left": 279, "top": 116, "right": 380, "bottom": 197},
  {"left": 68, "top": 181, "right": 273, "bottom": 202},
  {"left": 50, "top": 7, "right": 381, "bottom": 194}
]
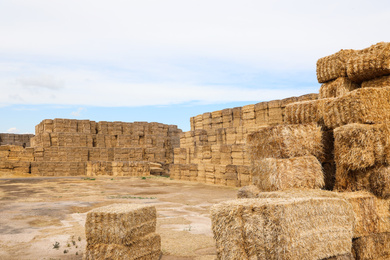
[{"left": 0, "top": 0, "right": 390, "bottom": 133}]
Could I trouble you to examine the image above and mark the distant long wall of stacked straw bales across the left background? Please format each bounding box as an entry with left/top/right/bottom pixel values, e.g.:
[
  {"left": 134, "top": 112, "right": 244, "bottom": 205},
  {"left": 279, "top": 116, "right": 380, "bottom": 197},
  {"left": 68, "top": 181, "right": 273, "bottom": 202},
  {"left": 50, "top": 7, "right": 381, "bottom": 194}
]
[{"left": 0, "top": 118, "right": 181, "bottom": 176}]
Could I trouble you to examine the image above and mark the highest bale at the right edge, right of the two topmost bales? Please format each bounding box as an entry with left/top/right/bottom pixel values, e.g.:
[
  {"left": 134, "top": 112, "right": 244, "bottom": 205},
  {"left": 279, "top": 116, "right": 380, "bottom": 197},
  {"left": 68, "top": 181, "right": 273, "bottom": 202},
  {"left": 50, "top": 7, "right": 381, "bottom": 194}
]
[{"left": 347, "top": 42, "right": 390, "bottom": 82}]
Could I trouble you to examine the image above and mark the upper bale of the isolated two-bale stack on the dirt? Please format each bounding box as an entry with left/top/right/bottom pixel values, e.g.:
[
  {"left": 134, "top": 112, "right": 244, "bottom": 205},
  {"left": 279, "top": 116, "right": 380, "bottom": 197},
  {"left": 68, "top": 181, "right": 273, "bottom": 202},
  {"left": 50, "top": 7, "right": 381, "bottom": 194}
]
[{"left": 85, "top": 204, "right": 156, "bottom": 245}]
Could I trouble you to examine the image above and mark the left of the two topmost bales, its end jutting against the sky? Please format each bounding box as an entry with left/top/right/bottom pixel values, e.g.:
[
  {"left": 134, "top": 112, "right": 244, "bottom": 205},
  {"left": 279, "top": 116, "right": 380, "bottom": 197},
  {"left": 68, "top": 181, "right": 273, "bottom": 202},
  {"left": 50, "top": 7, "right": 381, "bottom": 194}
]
[{"left": 317, "top": 47, "right": 355, "bottom": 83}]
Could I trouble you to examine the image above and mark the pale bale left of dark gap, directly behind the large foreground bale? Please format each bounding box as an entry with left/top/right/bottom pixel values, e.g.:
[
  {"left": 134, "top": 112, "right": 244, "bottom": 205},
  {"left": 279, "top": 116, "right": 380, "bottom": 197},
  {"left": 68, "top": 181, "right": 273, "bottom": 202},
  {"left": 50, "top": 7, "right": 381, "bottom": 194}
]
[{"left": 252, "top": 156, "right": 325, "bottom": 191}]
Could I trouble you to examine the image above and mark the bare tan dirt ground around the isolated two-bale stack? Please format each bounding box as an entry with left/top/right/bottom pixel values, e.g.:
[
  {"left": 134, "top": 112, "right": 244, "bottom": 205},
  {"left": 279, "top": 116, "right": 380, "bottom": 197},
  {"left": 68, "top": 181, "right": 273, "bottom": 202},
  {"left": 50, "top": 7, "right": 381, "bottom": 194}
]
[{"left": 0, "top": 173, "right": 237, "bottom": 260}]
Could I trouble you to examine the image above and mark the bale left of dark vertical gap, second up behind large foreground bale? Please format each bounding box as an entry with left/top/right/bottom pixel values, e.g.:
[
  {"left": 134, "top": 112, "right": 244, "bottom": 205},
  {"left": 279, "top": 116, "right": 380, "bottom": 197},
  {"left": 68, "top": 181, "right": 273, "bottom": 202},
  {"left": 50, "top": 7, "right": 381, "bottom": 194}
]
[{"left": 247, "top": 124, "right": 323, "bottom": 160}]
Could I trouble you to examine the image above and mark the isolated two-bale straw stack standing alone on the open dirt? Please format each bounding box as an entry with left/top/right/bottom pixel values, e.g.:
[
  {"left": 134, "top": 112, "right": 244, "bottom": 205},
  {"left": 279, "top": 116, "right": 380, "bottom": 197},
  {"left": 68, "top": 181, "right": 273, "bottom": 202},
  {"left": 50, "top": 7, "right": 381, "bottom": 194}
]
[{"left": 83, "top": 204, "right": 161, "bottom": 260}]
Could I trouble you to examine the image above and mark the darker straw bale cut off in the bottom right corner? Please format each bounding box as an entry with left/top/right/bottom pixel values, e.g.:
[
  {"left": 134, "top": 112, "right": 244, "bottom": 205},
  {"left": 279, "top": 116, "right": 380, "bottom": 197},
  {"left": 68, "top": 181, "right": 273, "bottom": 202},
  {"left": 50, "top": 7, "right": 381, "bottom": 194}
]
[{"left": 352, "top": 233, "right": 390, "bottom": 260}]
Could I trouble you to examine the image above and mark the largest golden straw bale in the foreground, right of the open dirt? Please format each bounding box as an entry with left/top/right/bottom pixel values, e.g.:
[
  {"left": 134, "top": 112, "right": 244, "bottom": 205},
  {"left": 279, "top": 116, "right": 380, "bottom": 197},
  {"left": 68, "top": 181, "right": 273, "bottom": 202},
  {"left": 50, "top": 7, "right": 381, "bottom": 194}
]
[{"left": 211, "top": 194, "right": 353, "bottom": 260}]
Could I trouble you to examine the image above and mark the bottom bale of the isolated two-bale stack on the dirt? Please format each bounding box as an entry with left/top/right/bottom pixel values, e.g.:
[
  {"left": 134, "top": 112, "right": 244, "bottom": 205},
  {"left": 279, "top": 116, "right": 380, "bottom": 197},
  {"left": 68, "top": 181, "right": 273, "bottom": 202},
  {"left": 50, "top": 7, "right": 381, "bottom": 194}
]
[{"left": 83, "top": 233, "right": 161, "bottom": 260}]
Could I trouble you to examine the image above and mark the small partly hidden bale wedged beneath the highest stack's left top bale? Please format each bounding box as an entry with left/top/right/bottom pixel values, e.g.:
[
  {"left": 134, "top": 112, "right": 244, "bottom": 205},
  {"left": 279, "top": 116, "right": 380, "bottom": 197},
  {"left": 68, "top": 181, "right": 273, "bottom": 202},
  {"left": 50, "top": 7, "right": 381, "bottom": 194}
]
[{"left": 318, "top": 77, "right": 360, "bottom": 99}]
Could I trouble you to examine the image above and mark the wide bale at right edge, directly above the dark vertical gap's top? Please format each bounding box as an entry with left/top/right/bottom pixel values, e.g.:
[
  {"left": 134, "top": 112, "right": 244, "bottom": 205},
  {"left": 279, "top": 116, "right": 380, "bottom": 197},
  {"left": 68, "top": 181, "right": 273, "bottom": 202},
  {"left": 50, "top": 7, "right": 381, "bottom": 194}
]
[{"left": 323, "top": 87, "right": 390, "bottom": 128}]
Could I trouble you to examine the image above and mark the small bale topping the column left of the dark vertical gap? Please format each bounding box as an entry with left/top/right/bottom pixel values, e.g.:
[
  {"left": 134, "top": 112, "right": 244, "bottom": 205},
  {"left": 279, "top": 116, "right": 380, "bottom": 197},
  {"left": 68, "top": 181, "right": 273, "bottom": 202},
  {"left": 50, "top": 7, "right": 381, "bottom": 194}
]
[{"left": 284, "top": 98, "right": 332, "bottom": 124}]
